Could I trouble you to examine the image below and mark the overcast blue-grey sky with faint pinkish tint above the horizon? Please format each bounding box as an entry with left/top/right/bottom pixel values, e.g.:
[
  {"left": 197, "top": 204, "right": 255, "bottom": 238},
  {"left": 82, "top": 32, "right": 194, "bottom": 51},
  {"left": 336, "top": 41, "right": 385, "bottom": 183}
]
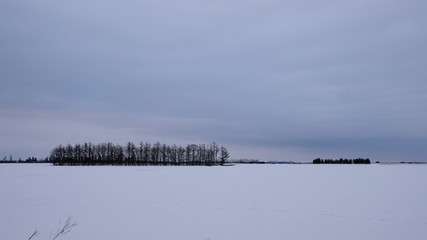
[{"left": 0, "top": 0, "right": 427, "bottom": 161}]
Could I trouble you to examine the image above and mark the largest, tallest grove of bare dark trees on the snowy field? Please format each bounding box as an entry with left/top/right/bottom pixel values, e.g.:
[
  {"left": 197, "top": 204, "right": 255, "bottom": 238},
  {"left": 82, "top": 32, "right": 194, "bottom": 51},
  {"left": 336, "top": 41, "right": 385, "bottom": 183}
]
[{"left": 49, "top": 142, "right": 229, "bottom": 166}]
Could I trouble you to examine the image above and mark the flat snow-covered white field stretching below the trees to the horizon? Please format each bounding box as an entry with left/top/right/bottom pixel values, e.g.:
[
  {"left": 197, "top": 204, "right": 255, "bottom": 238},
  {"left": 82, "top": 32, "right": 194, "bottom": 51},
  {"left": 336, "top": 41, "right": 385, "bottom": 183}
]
[{"left": 0, "top": 164, "right": 427, "bottom": 240}]
